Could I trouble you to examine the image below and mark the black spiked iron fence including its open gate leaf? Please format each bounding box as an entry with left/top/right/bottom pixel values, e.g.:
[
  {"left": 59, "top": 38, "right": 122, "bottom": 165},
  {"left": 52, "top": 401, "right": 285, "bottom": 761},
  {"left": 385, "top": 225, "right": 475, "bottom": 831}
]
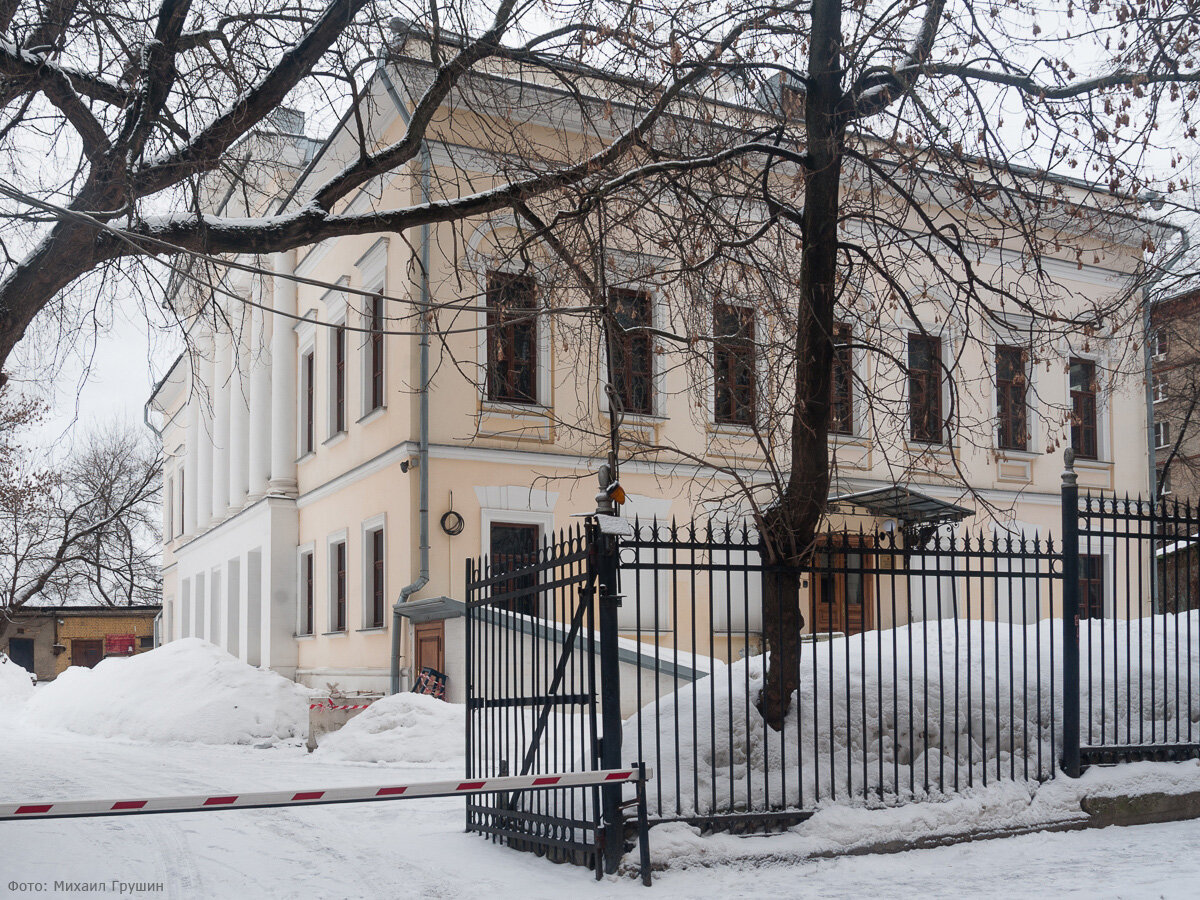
[{"left": 467, "top": 465, "right": 1200, "bottom": 844}]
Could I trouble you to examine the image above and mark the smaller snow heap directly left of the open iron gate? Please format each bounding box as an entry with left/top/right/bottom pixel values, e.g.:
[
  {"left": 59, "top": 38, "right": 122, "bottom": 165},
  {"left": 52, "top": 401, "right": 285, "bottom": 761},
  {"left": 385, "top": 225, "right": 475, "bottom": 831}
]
[{"left": 316, "top": 694, "right": 466, "bottom": 768}]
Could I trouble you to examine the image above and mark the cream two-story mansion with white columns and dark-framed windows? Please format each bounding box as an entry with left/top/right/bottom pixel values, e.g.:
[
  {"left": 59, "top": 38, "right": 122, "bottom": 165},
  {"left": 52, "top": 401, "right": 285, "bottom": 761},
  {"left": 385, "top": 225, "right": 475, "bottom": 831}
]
[{"left": 149, "top": 37, "right": 1166, "bottom": 697}]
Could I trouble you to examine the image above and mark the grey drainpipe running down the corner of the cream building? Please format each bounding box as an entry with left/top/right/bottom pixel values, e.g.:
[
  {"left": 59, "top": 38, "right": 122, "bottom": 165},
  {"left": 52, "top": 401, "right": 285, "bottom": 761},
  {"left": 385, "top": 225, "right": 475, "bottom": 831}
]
[{"left": 379, "top": 61, "right": 433, "bottom": 694}]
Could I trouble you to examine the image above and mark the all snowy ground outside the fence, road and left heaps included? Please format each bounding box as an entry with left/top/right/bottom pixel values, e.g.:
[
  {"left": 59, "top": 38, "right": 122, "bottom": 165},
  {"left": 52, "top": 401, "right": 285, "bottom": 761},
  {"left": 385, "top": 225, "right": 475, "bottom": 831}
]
[{"left": 0, "top": 642, "right": 1200, "bottom": 900}]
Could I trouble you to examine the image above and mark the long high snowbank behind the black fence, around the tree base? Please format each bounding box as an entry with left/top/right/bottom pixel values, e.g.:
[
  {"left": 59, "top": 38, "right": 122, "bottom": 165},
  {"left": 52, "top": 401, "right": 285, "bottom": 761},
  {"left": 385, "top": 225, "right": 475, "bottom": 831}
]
[{"left": 623, "top": 611, "right": 1200, "bottom": 816}]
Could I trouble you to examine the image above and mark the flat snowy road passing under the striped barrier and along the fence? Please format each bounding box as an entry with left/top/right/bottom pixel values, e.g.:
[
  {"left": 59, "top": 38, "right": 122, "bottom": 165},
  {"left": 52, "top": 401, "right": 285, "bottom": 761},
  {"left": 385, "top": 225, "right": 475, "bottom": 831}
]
[{"left": 0, "top": 725, "right": 1200, "bottom": 900}]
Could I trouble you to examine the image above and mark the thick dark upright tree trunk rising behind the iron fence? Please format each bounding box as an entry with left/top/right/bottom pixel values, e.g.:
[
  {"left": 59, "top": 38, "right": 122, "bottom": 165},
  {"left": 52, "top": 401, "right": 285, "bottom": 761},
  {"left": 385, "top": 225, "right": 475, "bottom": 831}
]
[{"left": 758, "top": 0, "right": 846, "bottom": 731}]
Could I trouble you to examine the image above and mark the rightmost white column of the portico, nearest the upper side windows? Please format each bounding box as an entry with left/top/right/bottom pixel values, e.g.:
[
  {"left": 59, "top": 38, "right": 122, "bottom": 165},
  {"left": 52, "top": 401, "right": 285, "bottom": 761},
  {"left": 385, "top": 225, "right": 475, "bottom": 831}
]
[{"left": 270, "top": 250, "right": 296, "bottom": 497}]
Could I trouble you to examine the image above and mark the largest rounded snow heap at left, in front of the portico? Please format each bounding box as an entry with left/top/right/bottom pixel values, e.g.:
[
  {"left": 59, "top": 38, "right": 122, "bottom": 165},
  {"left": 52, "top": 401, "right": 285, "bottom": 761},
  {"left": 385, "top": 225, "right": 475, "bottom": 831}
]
[{"left": 26, "top": 637, "right": 308, "bottom": 744}]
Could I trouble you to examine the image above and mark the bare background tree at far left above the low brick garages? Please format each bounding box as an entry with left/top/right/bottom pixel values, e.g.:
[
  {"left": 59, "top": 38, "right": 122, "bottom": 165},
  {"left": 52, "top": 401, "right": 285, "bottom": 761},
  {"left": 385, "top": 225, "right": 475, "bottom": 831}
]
[{"left": 0, "top": 420, "right": 162, "bottom": 634}]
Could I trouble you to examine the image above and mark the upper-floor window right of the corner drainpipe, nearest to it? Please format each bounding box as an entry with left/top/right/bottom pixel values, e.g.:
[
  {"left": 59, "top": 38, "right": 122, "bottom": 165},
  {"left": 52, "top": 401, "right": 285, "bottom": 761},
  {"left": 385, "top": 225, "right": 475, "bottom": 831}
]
[{"left": 487, "top": 272, "right": 538, "bottom": 403}]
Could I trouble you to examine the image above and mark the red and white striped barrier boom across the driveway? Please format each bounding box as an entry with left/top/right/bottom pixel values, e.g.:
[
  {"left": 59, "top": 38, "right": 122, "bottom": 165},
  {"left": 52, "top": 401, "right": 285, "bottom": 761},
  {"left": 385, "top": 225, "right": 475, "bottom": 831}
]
[{"left": 0, "top": 767, "right": 649, "bottom": 821}]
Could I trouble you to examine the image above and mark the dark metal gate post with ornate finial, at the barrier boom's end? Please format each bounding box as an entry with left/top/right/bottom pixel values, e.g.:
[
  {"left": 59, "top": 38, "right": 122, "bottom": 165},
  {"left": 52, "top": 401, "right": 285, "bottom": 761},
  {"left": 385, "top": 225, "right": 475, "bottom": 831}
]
[{"left": 588, "top": 466, "right": 625, "bottom": 874}]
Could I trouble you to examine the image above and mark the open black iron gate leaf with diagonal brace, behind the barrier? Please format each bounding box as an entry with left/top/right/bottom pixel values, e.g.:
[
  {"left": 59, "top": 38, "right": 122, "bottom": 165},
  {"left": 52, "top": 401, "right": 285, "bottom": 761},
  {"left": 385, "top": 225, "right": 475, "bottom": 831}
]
[{"left": 467, "top": 520, "right": 622, "bottom": 877}]
